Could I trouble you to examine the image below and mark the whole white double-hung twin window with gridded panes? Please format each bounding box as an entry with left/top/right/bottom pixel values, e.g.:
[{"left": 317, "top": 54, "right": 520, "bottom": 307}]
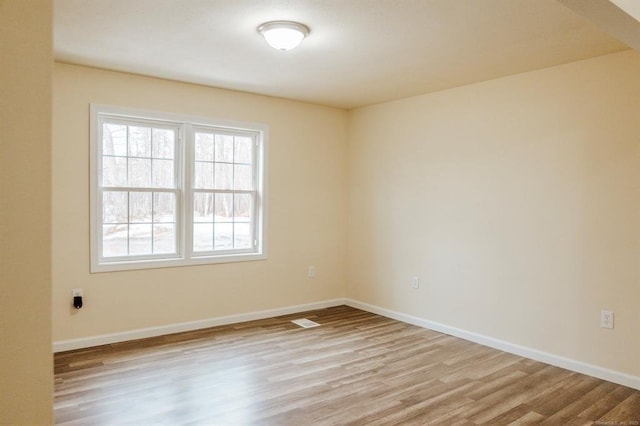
[{"left": 91, "top": 105, "right": 266, "bottom": 272}]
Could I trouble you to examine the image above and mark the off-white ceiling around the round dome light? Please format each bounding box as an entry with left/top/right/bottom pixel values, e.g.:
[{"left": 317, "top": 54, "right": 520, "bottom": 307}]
[{"left": 54, "top": 0, "right": 628, "bottom": 109}]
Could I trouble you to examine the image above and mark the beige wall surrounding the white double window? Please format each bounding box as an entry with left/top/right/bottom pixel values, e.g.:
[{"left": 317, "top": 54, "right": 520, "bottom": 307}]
[{"left": 53, "top": 64, "right": 347, "bottom": 341}]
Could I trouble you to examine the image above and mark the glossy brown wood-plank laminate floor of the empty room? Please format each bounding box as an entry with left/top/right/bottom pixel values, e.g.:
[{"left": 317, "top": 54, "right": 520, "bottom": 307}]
[{"left": 54, "top": 306, "right": 640, "bottom": 426}]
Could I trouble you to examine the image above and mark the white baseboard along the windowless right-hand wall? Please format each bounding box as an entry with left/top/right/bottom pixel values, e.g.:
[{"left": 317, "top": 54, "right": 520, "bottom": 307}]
[{"left": 345, "top": 299, "right": 640, "bottom": 390}]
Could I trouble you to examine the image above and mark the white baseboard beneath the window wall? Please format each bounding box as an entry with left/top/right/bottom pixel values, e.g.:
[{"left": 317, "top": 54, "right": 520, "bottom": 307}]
[{"left": 53, "top": 298, "right": 346, "bottom": 352}]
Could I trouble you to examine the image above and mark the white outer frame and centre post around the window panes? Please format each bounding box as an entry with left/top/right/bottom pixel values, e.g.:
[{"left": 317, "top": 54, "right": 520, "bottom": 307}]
[{"left": 90, "top": 104, "right": 268, "bottom": 273}]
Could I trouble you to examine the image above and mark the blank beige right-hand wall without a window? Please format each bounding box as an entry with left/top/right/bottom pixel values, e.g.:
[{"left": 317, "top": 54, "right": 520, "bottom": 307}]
[{"left": 347, "top": 51, "right": 640, "bottom": 376}]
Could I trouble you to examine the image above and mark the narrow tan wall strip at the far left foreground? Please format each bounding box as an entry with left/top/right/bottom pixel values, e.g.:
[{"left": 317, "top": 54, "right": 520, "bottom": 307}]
[{"left": 0, "top": 0, "right": 53, "bottom": 424}]
